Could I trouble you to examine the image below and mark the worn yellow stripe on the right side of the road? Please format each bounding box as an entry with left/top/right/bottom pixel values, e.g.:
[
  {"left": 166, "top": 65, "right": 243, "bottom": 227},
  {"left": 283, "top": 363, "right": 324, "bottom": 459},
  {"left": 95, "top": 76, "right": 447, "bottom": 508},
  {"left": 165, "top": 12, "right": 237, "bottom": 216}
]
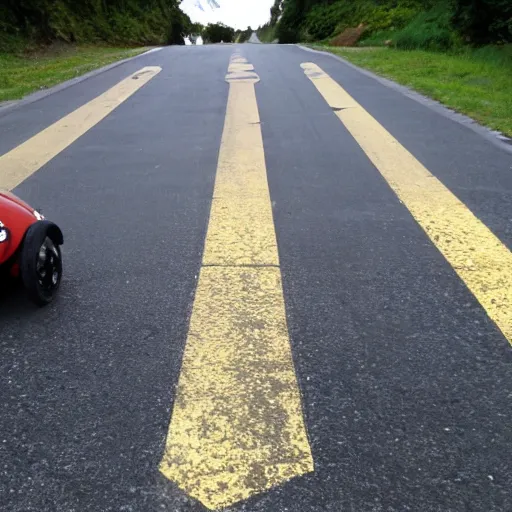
[{"left": 301, "top": 63, "right": 512, "bottom": 343}]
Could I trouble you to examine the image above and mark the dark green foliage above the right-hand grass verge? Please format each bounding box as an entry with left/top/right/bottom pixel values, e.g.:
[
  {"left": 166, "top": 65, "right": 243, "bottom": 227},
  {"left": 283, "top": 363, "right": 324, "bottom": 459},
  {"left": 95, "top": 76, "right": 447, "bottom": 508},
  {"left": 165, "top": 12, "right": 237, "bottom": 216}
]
[{"left": 267, "top": 0, "right": 512, "bottom": 46}]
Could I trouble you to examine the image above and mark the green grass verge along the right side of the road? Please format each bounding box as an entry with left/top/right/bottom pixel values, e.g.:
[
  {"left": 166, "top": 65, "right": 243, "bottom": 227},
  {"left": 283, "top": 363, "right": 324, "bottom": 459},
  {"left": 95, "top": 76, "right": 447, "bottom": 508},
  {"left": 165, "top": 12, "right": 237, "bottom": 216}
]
[{"left": 315, "top": 45, "right": 512, "bottom": 136}]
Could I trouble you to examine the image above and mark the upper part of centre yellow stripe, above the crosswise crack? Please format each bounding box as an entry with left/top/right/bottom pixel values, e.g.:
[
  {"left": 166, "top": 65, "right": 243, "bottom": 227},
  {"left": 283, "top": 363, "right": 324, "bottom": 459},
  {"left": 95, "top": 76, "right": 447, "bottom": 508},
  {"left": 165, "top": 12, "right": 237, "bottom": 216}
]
[{"left": 203, "top": 75, "right": 279, "bottom": 265}]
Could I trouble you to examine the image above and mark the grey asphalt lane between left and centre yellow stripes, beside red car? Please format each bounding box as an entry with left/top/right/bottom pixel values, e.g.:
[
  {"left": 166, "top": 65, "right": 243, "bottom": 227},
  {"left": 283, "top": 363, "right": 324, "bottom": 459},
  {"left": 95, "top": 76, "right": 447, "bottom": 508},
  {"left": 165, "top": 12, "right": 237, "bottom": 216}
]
[{"left": 0, "top": 48, "right": 232, "bottom": 512}]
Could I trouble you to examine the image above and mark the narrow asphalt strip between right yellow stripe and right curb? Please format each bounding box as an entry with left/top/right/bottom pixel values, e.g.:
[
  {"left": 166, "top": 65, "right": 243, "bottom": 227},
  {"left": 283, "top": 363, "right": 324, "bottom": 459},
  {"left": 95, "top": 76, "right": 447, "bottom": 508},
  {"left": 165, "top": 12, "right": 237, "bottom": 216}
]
[{"left": 292, "top": 49, "right": 512, "bottom": 250}]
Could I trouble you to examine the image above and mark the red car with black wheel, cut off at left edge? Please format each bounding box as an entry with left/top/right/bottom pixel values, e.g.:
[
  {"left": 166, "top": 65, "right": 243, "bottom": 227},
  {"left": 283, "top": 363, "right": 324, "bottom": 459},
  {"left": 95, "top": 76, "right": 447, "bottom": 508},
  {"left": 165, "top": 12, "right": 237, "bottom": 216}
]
[{"left": 0, "top": 191, "right": 64, "bottom": 306}]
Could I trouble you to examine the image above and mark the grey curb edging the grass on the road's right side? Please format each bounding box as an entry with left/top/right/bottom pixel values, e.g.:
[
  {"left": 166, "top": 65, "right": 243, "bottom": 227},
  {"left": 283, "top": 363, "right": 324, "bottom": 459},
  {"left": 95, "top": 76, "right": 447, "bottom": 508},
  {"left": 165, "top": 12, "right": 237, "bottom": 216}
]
[{"left": 295, "top": 44, "right": 512, "bottom": 153}]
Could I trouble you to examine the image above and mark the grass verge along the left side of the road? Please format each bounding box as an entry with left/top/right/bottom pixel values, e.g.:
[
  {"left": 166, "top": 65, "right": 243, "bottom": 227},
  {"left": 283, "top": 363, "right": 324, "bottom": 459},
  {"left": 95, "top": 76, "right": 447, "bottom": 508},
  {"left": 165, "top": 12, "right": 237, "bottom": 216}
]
[{"left": 0, "top": 46, "right": 146, "bottom": 101}]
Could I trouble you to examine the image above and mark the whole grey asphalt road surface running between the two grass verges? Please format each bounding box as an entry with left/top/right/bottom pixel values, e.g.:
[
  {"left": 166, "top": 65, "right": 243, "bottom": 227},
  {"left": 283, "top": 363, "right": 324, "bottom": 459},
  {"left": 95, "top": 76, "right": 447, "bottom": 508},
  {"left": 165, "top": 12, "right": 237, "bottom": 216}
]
[{"left": 0, "top": 45, "right": 512, "bottom": 512}]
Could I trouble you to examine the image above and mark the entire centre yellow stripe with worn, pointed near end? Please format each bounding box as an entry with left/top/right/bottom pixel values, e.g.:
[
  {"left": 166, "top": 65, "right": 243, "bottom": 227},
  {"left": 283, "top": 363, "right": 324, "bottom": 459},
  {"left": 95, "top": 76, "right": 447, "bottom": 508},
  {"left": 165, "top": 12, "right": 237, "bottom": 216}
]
[{"left": 160, "top": 57, "right": 313, "bottom": 510}]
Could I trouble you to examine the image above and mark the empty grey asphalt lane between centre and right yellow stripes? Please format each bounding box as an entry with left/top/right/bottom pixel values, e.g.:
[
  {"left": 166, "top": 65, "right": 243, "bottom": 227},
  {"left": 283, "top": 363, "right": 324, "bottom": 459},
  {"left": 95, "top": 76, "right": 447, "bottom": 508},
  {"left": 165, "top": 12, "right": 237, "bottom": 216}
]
[{"left": 247, "top": 46, "right": 512, "bottom": 511}]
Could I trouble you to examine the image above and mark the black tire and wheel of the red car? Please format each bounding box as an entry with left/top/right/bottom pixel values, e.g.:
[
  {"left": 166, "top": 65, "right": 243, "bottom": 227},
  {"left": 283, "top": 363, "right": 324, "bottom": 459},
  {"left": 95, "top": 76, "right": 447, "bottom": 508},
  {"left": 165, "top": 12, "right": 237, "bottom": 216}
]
[{"left": 20, "top": 221, "right": 62, "bottom": 306}]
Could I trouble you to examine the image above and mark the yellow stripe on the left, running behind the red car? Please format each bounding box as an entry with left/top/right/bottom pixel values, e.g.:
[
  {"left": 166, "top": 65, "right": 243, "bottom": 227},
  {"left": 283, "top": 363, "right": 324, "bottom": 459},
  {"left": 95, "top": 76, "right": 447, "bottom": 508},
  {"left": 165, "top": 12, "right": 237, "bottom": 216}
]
[{"left": 0, "top": 67, "right": 162, "bottom": 190}]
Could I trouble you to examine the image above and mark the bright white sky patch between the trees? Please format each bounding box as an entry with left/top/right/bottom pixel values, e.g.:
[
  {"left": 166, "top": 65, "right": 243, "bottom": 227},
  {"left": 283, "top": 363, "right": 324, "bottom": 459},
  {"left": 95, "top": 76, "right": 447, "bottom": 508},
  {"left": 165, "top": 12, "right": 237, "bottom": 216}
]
[{"left": 181, "top": 0, "right": 274, "bottom": 29}]
